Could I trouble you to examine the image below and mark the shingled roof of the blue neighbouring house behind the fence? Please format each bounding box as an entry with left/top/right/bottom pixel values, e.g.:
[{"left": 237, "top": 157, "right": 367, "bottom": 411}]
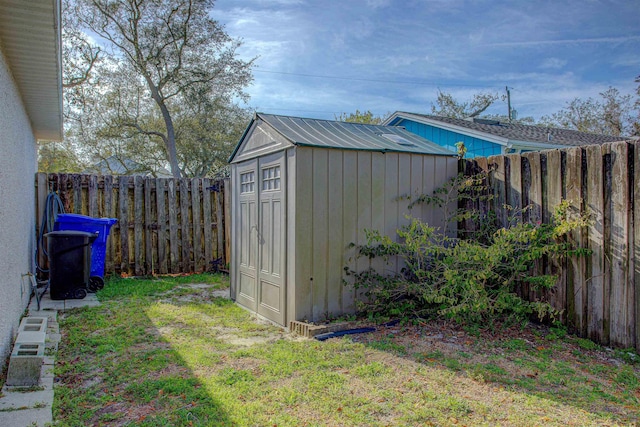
[{"left": 384, "top": 111, "right": 628, "bottom": 148}]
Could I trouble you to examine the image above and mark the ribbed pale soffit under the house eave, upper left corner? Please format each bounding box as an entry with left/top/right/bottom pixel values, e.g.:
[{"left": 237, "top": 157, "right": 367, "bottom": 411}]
[{"left": 0, "top": 0, "right": 62, "bottom": 141}]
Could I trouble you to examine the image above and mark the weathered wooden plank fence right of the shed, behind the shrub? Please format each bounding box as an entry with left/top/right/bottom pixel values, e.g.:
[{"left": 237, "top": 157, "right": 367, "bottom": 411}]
[{"left": 460, "top": 142, "right": 640, "bottom": 350}]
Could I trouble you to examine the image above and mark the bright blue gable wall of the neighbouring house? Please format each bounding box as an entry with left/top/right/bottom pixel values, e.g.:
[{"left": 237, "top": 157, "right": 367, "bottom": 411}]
[{"left": 390, "top": 119, "right": 502, "bottom": 158}]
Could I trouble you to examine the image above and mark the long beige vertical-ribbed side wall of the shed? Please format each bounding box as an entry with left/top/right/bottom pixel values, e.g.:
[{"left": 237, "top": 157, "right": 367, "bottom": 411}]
[{"left": 287, "top": 147, "right": 457, "bottom": 321}]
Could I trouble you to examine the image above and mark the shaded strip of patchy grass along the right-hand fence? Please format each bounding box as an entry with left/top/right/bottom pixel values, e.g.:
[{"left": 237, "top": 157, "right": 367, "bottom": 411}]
[{"left": 356, "top": 325, "right": 640, "bottom": 424}]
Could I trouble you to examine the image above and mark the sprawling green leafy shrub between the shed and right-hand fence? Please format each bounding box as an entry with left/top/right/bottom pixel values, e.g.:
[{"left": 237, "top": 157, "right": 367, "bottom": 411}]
[{"left": 345, "top": 174, "right": 589, "bottom": 326}]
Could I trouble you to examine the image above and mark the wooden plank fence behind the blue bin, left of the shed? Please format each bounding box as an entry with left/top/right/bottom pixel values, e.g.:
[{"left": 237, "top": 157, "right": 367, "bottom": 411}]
[{"left": 36, "top": 173, "right": 230, "bottom": 276}]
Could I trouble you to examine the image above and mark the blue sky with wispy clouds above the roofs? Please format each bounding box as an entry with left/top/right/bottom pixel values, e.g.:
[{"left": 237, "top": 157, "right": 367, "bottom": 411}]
[{"left": 213, "top": 0, "right": 640, "bottom": 119}]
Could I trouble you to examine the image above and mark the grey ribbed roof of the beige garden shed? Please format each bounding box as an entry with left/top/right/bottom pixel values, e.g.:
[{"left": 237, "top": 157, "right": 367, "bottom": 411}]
[{"left": 229, "top": 113, "right": 455, "bottom": 162}]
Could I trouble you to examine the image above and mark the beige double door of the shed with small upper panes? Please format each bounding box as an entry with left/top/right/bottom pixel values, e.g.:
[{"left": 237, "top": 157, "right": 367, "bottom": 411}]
[{"left": 236, "top": 152, "right": 286, "bottom": 326}]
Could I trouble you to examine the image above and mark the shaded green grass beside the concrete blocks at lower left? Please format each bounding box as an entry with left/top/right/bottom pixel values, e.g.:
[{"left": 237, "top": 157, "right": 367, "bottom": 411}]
[{"left": 53, "top": 276, "right": 232, "bottom": 426}]
